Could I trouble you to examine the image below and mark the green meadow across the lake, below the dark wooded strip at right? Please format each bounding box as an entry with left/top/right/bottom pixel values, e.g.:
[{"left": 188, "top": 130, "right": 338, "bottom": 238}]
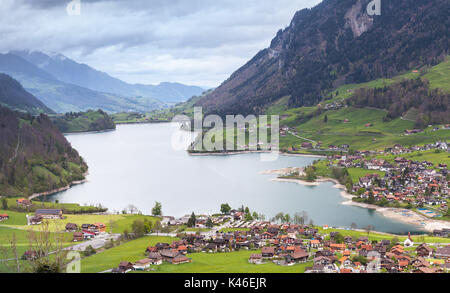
[{"left": 281, "top": 107, "right": 450, "bottom": 150}]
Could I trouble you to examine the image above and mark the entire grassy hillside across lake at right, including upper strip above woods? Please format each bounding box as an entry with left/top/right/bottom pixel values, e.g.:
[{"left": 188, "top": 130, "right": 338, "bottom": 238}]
[{"left": 278, "top": 59, "right": 450, "bottom": 150}]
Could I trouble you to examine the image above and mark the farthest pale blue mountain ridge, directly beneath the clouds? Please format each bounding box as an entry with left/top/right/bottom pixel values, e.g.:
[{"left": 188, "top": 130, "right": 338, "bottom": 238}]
[{"left": 10, "top": 51, "right": 204, "bottom": 104}]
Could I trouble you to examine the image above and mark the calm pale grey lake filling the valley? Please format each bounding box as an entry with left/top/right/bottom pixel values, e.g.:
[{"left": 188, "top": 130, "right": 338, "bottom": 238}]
[{"left": 49, "top": 123, "right": 419, "bottom": 234}]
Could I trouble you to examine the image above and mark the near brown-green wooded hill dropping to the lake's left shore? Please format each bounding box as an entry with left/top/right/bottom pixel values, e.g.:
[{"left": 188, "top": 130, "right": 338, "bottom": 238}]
[{"left": 0, "top": 107, "right": 88, "bottom": 196}]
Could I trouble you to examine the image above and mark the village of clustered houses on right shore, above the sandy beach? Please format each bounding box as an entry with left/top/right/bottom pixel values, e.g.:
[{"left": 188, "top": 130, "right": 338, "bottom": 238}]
[{"left": 328, "top": 143, "right": 450, "bottom": 218}]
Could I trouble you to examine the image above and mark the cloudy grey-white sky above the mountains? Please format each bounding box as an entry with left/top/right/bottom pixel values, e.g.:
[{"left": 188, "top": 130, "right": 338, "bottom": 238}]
[{"left": 0, "top": 0, "right": 320, "bottom": 87}]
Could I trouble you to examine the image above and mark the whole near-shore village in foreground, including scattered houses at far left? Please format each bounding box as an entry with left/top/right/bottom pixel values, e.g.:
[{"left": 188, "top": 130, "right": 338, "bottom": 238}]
[{"left": 1, "top": 193, "right": 450, "bottom": 273}]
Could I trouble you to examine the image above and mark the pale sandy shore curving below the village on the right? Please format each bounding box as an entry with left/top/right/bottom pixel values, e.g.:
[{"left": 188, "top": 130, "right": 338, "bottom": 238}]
[{"left": 266, "top": 170, "right": 450, "bottom": 232}]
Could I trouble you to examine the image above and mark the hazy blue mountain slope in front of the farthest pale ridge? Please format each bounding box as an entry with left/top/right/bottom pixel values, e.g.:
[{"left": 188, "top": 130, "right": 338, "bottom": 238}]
[{"left": 0, "top": 54, "right": 165, "bottom": 113}]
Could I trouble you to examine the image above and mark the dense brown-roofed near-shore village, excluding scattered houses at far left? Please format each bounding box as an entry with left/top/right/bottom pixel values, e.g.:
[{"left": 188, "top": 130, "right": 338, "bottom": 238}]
[{"left": 111, "top": 210, "right": 450, "bottom": 273}]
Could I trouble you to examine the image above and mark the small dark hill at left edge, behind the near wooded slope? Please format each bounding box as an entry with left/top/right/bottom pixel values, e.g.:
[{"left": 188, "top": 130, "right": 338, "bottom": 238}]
[{"left": 0, "top": 73, "right": 54, "bottom": 115}]
